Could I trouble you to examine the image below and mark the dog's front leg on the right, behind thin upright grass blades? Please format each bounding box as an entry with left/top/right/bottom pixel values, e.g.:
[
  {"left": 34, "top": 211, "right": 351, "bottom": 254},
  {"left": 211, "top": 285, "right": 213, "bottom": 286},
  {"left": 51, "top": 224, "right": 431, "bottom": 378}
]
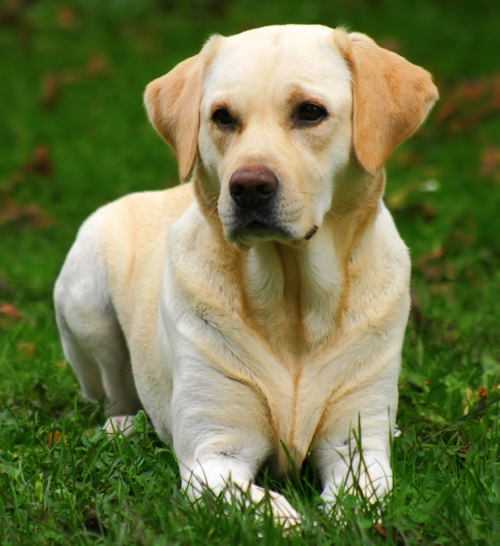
[{"left": 315, "top": 356, "right": 399, "bottom": 505}]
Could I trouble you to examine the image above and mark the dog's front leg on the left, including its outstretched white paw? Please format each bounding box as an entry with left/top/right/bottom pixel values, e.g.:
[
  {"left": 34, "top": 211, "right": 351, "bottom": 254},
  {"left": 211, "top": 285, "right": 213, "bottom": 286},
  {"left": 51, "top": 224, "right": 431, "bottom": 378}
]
[{"left": 172, "top": 365, "right": 300, "bottom": 527}]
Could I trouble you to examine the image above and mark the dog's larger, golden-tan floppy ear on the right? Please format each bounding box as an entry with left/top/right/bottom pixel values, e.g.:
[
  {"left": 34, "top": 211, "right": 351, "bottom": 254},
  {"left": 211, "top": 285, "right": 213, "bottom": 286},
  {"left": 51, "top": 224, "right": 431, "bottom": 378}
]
[{"left": 334, "top": 30, "right": 439, "bottom": 174}]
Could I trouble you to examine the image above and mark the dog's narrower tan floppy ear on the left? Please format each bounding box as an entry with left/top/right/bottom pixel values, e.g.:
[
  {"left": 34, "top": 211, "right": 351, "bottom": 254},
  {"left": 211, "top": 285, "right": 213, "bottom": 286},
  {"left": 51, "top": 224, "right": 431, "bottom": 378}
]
[{"left": 144, "top": 37, "right": 217, "bottom": 181}]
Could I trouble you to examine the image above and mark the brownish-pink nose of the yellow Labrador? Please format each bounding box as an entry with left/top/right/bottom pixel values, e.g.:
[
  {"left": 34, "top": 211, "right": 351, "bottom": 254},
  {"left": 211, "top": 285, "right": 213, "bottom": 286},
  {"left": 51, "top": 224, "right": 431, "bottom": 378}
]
[{"left": 229, "top": 165, "right": 278, "bottom": 208}]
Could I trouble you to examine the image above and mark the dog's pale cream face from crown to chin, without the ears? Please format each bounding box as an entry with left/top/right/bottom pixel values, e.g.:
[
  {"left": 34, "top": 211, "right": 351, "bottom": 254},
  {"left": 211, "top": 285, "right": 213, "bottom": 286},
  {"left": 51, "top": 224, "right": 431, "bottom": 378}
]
[{"left": 198, "top": 27, "right": 352, "bottom": 245}]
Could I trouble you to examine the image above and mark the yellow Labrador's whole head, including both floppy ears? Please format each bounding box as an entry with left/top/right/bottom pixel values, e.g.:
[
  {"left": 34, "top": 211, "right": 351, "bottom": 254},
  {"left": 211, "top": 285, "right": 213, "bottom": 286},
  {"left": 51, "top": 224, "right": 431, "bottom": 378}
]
[{"left": 145, "top": 25, "right": 438, "bottom": 247}]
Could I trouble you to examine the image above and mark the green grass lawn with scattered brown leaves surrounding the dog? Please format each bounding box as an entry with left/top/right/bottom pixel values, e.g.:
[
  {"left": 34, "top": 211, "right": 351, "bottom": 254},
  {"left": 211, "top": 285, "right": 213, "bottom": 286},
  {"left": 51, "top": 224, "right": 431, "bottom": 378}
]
[{"left": 0, "top": 0, "right": 500, "bottom": 546}]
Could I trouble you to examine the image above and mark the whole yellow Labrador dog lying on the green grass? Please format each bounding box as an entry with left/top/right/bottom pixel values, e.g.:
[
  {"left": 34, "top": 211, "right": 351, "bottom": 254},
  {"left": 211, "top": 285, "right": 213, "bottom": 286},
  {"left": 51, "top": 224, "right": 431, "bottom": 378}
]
[{"left": 54, "top": 25, "right": 438, "bottom": 525}]
